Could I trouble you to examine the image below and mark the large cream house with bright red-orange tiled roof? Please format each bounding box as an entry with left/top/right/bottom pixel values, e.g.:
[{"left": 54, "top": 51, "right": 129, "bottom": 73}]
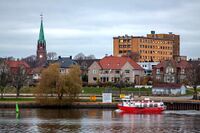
[{"left": 88, "top": 56, "right": 144, "bottom": 84}]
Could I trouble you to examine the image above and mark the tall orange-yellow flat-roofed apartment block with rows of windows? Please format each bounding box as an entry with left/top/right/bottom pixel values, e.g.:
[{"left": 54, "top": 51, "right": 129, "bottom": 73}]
[{"left": 113, "top": 31, "right": 180, "bottom": 62}]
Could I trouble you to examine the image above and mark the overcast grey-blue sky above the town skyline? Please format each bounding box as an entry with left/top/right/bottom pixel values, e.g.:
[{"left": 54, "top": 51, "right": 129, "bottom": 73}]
[{"left": 0, "top": 0, "right": 200, "bottom": 58}]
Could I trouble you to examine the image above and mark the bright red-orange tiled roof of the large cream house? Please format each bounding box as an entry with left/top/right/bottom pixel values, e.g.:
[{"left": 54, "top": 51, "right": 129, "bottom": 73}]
[{"left": 99, "top": 56, "right": 143, "bottom": 70}]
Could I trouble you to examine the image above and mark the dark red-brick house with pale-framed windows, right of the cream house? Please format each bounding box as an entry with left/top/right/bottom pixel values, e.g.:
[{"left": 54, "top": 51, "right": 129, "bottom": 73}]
[{"left": 153, "top": 60, "right": 189, "bottom": 83}]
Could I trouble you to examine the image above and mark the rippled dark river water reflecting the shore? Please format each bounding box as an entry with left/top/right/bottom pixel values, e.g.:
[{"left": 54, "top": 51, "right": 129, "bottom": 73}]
[{"left": 0, "top": 109, "right": 200, "bottom": 133}]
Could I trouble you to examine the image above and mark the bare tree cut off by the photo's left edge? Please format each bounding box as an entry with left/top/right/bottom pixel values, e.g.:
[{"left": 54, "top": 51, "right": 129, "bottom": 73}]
[{"left": 0, "top": 62, "right": 11, "bottom": 98}]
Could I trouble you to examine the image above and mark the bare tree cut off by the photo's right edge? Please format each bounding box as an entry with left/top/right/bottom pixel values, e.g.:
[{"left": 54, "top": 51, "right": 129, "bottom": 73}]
[{"left": 186, "top": 61, "right": 200, "bottom": 99}]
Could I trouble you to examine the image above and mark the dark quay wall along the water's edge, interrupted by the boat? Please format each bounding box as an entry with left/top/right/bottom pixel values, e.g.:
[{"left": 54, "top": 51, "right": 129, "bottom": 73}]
[{"left": 0, "top": 100, "right": 200, "bottom": 110}]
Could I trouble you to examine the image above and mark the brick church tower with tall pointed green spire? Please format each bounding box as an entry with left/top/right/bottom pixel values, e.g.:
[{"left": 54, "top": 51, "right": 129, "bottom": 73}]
[{"left": 37, "top": 15, "right": 47, "bottom": 65}]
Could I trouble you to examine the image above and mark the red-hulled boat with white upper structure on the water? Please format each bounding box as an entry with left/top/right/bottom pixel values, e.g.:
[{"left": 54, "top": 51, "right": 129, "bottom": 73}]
[{"left": 118, "top": 96, "right": 166, "bottom": 114}]
